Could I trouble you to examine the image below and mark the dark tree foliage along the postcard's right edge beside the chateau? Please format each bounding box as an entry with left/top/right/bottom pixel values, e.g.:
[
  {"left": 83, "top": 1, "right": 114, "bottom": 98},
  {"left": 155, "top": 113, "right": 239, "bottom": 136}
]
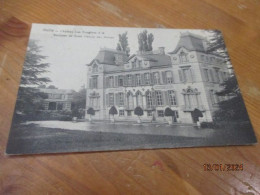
[{"left": 208, "top": 30, "right": 249, "bottom": 121}]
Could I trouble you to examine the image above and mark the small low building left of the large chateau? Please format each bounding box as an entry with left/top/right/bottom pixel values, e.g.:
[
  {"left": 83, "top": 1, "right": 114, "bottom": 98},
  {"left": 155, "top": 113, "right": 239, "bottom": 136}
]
[{"left": 39, "top": 88, "right": 73, "bottom": 111}]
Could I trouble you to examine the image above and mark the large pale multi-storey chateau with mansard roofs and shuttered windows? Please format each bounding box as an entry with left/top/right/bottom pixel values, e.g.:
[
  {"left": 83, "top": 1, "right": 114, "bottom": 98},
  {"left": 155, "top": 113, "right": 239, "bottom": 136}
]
[{"left": 86, "top": 32, "right": 229, "bottom": 123}]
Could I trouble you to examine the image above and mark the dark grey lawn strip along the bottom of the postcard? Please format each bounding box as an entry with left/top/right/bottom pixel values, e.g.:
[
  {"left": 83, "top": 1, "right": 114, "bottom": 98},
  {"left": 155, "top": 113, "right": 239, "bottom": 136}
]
[{"left": 7, "top": 124, "right": 255, "bottom": 154}]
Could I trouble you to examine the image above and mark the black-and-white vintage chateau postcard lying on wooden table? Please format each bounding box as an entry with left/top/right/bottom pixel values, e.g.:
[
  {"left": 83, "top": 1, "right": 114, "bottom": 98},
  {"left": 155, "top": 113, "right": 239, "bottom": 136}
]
[{"left": 6, "top": 24, "right": 257, "bottom": 154}]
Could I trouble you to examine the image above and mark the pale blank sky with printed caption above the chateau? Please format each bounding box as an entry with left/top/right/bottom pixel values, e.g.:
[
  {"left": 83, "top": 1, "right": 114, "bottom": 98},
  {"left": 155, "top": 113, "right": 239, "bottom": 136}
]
[{"left": 30, "top": 24, "right": 207, "bottom": 90}]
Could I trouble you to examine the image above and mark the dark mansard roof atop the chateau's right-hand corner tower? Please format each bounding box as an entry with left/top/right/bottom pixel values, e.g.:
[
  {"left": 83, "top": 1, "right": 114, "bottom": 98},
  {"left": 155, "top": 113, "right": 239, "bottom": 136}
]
[{"left": 169, "top": 32, "right": 206, "bottom": 54}]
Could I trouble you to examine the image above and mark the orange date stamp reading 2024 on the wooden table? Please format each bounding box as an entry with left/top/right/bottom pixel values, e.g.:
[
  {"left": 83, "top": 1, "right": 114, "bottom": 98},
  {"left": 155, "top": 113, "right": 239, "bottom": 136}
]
[{"left": 203, "top": 163, "right": 244, "bottom": 171}]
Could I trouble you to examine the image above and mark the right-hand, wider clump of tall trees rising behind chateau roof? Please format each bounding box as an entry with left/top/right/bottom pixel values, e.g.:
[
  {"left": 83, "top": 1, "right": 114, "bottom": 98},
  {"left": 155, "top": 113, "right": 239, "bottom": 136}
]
[{"left": 138, "top": 30, "right": 154, "bottom": 51}]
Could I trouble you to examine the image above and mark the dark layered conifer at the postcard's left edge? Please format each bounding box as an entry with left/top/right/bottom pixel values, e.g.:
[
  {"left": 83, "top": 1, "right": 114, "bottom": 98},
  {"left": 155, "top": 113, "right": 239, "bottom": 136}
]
[{"left": 16, "top": 40, "right": 50, "bottom": 117}]
